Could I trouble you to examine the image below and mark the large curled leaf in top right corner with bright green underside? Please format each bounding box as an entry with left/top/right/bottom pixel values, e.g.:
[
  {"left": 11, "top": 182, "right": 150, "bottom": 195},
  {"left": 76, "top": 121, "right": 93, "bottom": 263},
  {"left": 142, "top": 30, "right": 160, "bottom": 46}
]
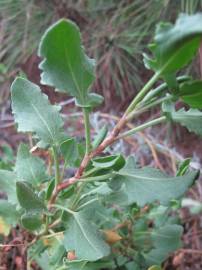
[{"left": 145, "top": 13, "right": 202, "bottom": 75}]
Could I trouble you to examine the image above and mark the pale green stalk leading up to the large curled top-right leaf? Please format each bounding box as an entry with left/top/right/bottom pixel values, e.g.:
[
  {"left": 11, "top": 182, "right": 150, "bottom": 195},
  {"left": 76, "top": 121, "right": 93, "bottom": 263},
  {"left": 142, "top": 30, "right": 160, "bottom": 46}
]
[{"left": 125, "top": 72, "right": 160, "bottom": 115}]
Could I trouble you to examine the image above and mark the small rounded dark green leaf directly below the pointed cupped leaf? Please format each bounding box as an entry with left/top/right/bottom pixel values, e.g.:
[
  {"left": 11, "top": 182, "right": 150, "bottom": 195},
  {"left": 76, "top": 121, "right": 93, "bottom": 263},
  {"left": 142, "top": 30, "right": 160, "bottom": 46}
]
[{"left": 21, "top": 211, "right": 42, "bottom": 231}]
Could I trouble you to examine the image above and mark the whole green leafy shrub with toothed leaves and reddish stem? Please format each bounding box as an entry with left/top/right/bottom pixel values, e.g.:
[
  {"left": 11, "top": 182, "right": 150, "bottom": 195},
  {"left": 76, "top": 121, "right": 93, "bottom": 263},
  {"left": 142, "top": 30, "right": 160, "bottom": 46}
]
[{"left": 0, "top": 14, "right": 202, "bottom": 270}]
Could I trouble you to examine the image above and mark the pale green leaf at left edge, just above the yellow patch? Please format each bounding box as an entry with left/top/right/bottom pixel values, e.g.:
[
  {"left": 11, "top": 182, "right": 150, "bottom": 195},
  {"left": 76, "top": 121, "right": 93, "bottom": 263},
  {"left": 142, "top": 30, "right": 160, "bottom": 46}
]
[{"left": 0, "top": 200, "right": 18, "bottom": 226}]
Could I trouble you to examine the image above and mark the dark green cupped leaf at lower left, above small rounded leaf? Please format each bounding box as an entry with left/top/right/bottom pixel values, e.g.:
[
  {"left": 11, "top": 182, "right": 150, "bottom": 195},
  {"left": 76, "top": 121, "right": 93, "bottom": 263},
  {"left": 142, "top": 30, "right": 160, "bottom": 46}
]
[{"left": 16, "top": 181, "right": 46, "bottom": 212}]
